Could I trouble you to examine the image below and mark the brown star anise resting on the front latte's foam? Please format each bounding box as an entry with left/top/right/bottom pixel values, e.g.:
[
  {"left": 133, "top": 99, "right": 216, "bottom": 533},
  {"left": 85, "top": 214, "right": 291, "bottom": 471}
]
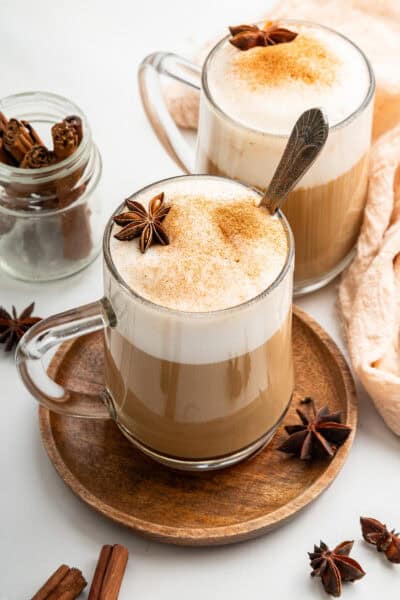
[{"left": 114, "top": 192, "right": 171, "bottom": 253}]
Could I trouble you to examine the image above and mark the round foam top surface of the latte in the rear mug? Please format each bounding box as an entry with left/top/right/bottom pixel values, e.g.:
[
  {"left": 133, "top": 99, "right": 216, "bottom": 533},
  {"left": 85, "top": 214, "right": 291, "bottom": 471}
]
[{"left": 208, "top": 25, "right": 369, "bottom": 134}]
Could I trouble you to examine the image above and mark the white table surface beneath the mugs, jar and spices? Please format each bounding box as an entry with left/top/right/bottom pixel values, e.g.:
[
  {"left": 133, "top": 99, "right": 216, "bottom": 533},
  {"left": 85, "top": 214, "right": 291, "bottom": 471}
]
[{"left": 0, "top": 0, "right": 400, "bottom": 600}]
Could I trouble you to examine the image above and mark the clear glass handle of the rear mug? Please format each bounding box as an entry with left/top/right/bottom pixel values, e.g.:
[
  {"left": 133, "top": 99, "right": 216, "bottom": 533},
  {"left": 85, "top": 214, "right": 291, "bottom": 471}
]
[{"left": 138, "top": 52, "right": 201, "bottom": 173}]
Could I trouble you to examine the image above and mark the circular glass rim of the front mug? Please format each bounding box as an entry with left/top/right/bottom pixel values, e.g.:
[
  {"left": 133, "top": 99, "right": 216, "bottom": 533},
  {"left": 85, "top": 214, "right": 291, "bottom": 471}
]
[{"left": 103, "top": 174, "right": 295, "bottom": 319}]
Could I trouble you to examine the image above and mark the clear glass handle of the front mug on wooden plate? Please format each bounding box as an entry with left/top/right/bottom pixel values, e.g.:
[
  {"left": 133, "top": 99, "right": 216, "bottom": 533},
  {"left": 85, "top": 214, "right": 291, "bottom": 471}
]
[{"left": 15, "top": 298, "right": 115, "bottom": 419}]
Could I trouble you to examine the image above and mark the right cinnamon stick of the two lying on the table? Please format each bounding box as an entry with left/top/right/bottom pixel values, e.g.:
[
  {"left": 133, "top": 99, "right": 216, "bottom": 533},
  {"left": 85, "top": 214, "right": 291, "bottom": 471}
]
[{"left": 88, "top": 544, "right": 129, "bottom": 600}]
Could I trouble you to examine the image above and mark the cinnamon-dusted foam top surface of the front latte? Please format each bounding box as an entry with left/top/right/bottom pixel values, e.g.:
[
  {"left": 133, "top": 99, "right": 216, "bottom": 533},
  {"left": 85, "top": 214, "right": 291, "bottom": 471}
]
[{"left": 111, "top": 178, "right": 288, "bottom": 312}]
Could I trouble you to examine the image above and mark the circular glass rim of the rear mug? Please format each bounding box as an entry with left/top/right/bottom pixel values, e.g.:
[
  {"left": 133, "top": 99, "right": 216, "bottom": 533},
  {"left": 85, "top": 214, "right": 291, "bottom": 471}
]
[{"left": 201, "top": 19, "right": 375, "bottom": 139}]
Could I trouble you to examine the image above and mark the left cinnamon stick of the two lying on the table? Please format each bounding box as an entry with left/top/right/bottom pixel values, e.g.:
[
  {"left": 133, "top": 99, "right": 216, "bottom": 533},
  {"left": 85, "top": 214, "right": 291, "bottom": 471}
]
[{"left": 32, "top": 565, "right": 86, "bottom": 600}]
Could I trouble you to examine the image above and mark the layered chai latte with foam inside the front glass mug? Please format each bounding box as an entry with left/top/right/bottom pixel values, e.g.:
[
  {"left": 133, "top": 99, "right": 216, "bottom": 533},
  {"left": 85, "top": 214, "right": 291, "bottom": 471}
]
[{"left": 105, "top": 176, "right": 294, "bottom": 460}]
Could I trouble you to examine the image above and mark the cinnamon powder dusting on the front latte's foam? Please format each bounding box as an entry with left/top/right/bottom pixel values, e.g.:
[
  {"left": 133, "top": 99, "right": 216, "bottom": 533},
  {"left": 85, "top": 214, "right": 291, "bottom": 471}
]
[{"left": 126, "top": 197, "right": 287, "bottom": 310}]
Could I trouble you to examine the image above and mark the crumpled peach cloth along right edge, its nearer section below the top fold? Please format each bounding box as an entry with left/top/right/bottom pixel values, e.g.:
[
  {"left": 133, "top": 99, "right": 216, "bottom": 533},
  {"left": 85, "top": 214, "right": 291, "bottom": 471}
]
[{"left": 339, "top": 125, "right": 400, "bottom": 435}]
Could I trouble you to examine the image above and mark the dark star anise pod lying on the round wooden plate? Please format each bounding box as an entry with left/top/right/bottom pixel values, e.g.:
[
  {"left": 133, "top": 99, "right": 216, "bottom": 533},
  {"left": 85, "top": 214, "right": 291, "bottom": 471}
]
[{"left": 278, "top": 398, "right": 351, "bottom": 460}]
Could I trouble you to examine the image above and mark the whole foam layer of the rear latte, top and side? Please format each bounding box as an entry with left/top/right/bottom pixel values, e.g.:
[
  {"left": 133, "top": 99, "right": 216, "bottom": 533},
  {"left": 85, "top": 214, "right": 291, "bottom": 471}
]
[{"left": 200, "top": 23, "right": 374, "bottom": 189}]
